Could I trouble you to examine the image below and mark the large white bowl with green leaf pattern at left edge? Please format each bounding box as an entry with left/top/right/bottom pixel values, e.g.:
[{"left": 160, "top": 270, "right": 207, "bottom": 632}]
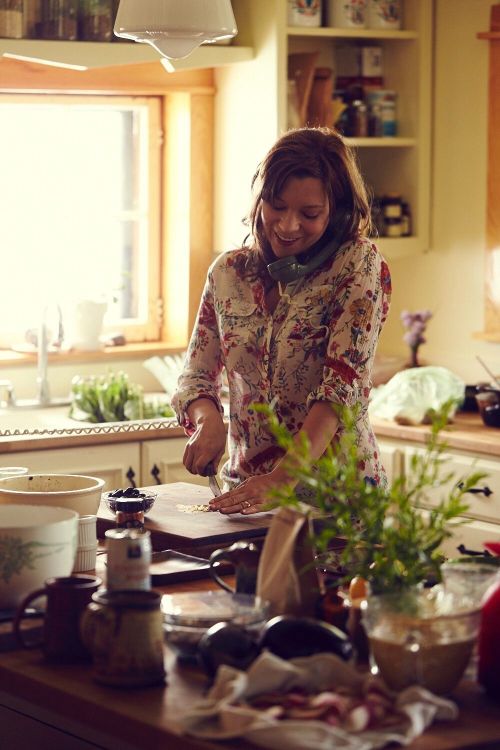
[{"left": 0, "top": 505, "right": 79, "bottom": 609}]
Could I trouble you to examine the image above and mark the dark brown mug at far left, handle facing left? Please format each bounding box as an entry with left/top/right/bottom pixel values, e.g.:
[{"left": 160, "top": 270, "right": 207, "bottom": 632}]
[{"left": 13, "top": 575, "right": 102, "bottom": 662}]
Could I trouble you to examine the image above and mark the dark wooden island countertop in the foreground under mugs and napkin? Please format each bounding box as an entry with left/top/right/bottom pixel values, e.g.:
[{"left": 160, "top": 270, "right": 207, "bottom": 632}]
[{"left": 0, "top": 579, "right": 500, "bottom": 750}]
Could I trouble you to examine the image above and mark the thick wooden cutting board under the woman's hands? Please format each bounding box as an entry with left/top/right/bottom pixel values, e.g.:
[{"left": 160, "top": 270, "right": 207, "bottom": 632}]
[{"left": 97, "top": 482, "right": 274, "bottom": 556}]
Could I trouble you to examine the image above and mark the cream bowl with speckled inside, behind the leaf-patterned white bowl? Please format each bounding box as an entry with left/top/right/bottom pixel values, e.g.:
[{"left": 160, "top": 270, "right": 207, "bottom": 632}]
[{"left": 0, "top": 474, "right": 104, "bottom": 516}]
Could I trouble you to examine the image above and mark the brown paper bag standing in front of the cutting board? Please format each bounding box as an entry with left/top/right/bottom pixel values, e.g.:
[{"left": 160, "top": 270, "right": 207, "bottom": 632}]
[{"left": 256, "top": 508, "right": 320, "bottom": 617}]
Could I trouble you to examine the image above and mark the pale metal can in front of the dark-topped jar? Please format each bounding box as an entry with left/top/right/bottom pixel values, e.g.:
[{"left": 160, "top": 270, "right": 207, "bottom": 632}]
[{"left": 105, "top": 529, "right": 151, "bottom": 591}]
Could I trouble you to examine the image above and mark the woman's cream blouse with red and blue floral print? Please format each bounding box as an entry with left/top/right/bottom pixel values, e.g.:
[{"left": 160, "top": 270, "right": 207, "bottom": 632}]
[{"left": 172, "top": 238, "right": 391, "bottom": 489}]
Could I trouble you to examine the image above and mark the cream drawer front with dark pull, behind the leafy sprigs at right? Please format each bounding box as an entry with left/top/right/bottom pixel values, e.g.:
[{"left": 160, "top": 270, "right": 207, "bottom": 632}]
[{"left": 405, "top": 448, "right": 500, "bottom": 523}]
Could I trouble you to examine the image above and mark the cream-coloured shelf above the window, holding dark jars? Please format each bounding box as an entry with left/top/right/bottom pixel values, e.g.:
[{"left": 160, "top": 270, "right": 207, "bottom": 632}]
[{"left": 0, "top": 39, "right": 254, "bottom": 70}]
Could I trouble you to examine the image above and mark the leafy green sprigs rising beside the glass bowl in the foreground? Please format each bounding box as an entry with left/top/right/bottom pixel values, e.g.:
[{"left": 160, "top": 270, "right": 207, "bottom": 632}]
[{"left": 255, "top": 401, "right": 485, "bottom": 593}]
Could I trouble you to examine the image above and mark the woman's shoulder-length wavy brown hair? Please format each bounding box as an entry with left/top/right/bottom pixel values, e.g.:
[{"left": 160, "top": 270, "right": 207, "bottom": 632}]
[{"left": 236, "top": 127, "right": 372, "bottom": 284}]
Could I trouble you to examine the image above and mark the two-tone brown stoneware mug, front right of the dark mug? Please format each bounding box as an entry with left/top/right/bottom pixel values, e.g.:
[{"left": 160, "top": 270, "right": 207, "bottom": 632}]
[{"left": 81, "top": 589, "right": 165, "bottom": 688}]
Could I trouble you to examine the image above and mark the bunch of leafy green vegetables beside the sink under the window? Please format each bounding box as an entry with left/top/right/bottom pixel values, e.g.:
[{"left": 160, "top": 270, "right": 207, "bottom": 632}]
[{"left": 70, "top": 372, "right": 174, "bottom": 422}]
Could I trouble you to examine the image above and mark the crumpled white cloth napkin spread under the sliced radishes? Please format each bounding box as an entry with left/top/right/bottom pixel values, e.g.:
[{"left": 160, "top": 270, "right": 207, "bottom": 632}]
[{"left": 181, "top": 651, "right": 458, "bottom": 750}]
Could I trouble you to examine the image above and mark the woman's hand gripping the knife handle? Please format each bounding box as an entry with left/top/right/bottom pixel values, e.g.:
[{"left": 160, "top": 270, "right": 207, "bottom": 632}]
[{"left": 183, "top": 409, "right": 226, "bottom": 476}]
